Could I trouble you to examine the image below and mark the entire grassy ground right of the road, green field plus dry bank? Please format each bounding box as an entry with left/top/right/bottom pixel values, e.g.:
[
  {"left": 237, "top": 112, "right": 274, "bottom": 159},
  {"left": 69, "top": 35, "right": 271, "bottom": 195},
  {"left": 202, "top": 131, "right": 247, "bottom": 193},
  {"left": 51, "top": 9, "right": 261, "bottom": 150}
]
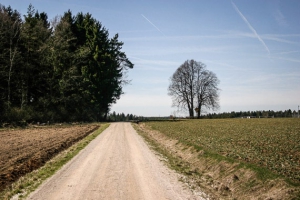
[{"left": 133, "top": 119, "right": 300, "bottom": 199}]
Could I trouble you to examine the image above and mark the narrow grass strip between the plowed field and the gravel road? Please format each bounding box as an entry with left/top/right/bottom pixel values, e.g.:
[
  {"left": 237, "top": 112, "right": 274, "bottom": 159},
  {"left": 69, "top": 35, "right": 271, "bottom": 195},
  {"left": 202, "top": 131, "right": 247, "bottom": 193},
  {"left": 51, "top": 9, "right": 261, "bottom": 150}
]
[{"left": 0, "top": 123, "right": 110, "bottom": 200}]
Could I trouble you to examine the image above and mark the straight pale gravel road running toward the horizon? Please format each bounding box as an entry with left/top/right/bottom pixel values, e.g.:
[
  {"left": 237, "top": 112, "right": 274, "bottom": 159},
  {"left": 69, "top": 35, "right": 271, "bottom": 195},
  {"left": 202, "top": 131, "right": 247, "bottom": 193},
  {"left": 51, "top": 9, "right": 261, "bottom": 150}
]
[{"left": 28, "top": 123, "right": 206, "bottom": 200}]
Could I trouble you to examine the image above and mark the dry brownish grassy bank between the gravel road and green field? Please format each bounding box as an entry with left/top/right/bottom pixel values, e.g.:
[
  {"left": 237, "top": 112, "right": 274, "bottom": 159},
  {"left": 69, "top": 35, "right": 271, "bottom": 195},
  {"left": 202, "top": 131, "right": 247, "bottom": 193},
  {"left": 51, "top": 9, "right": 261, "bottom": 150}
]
[{"left": 136, "top": 123, "right": 300, "bottom": 200}]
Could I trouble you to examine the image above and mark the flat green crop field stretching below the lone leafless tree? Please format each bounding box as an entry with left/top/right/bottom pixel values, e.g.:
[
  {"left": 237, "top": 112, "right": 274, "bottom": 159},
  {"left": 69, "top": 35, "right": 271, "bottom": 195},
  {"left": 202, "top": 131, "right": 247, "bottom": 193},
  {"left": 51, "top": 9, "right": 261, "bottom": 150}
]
[{"left": 147, "top": 118, "right": 300, "bottom": 184}]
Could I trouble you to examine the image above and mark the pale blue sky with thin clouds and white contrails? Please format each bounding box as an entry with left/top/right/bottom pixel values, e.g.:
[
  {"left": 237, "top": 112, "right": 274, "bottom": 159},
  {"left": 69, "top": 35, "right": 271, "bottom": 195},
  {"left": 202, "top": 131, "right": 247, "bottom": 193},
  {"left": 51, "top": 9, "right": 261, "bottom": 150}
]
[{"left": 1, "top": 0, "right": 300, "bottom": 116}]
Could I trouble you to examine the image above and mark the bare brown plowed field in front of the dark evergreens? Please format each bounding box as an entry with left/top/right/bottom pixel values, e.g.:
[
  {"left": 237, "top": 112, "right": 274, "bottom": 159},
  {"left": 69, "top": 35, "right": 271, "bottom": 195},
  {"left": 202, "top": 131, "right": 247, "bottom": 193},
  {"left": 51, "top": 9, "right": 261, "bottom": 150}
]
[{"left": 0, "top": 125, "right": 99, "bottom": 191}]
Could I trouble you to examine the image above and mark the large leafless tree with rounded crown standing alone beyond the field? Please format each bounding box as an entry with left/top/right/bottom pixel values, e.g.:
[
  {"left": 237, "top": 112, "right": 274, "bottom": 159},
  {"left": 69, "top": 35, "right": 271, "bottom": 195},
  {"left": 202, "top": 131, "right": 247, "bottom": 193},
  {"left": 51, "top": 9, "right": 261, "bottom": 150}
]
[{"left": 168, "top": 60, "right": 219, "bottom": 118}]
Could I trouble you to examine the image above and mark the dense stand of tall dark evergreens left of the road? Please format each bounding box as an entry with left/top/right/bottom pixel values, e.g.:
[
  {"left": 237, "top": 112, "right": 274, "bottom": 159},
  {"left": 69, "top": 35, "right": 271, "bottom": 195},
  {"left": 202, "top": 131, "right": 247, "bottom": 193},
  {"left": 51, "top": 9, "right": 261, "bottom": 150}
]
[{"left": 0, "top": 4, "right": 133, "bottom": 123}]
